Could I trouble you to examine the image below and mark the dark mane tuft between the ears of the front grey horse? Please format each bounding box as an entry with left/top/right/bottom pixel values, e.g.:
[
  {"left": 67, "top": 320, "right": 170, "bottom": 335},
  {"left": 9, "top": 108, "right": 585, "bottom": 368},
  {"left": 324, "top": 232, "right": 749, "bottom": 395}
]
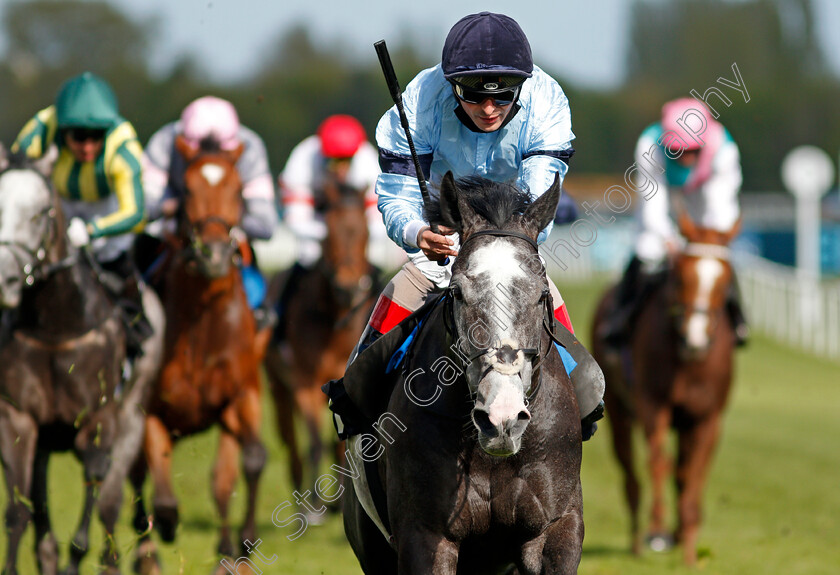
[{"left": 425, "top": 176, "right": 532, "bottom": 229}]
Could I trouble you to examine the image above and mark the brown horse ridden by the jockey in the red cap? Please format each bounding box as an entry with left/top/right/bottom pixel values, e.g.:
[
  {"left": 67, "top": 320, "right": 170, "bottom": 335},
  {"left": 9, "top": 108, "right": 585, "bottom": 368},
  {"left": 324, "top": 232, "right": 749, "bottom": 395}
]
[{"left": 265, "top": 177, "right": 379, "bottom": 521}]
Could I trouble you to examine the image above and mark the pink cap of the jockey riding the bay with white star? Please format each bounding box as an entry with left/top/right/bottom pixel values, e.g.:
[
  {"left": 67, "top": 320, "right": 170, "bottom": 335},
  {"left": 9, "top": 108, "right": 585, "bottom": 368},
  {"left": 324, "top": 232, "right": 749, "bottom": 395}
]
[{"left": 181, "top": 96, "right": 239, "bottom": 150}]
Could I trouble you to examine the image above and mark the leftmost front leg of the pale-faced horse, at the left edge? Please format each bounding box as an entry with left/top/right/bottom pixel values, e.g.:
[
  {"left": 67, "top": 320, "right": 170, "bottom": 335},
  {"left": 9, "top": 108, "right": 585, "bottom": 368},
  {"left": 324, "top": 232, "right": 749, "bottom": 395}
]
[{"left": 0, "top": 405, "right": 38, "bottom": 575}]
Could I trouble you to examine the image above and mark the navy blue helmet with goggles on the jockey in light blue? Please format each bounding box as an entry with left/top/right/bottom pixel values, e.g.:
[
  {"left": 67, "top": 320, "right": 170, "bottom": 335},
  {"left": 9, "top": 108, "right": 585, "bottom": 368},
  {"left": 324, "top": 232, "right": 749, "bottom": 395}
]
[{"left": 441, "top": 12, "right": 534, "bottom": 106}]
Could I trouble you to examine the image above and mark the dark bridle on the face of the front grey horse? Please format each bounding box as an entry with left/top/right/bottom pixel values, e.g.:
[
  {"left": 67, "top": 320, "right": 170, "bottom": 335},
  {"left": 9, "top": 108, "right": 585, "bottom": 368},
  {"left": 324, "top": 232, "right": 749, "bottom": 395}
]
[{"left": 441, "top": 229, "right": 565, "bottom": 402}]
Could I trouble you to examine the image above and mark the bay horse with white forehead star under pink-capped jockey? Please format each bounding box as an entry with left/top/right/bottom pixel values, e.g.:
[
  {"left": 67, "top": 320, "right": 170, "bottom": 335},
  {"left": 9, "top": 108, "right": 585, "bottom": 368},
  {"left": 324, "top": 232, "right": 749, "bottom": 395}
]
[{"left": 132, "top": 137, "right": 270, "bottom": 573}]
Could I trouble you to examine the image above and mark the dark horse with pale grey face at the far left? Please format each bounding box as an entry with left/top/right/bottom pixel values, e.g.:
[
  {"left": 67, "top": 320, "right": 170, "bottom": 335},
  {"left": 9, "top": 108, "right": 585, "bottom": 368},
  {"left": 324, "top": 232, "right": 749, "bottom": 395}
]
[{"left": 0, "top": 149, "right": 163, "bottom": 575}]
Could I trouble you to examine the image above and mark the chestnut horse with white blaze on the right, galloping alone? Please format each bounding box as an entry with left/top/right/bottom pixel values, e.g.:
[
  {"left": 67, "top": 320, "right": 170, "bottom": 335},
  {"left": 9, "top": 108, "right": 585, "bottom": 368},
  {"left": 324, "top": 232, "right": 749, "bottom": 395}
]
[{"left": 592, "top": 212, "right": 739, "bottom": 565}]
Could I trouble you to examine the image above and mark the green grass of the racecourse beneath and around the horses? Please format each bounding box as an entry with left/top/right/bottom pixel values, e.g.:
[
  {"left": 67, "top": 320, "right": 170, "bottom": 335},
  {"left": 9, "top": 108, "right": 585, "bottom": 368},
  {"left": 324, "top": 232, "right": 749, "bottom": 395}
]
[{"left": 0, "top": 281, "right": 840, "bottom": 575}]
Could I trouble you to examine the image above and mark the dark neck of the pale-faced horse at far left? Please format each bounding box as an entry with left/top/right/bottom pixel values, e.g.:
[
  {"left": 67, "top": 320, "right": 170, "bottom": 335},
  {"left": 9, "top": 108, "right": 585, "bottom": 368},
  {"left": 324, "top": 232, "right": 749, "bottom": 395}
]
[{"left": 18, "top": 261, "right": 113, "bottom": 339}]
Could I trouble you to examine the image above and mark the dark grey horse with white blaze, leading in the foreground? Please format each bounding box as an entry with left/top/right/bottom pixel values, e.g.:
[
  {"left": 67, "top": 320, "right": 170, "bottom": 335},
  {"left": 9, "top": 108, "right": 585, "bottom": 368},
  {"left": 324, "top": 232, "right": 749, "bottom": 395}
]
[{"left": 343, "top": 172, "right": 584, "bottom": 575}]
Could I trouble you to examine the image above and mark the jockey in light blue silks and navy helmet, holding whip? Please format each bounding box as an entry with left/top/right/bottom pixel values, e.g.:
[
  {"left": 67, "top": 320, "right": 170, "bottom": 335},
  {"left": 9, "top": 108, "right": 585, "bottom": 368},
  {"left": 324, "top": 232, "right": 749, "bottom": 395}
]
[{"left": 351, "top": 12, "right": 604, "bottom": 438}]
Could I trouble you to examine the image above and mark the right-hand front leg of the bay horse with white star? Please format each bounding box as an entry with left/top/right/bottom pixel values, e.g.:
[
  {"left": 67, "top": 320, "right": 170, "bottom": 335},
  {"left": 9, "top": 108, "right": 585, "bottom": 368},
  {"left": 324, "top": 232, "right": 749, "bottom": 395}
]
[{"left": 222, "top": 384, "right": 267, "bottom": 555}]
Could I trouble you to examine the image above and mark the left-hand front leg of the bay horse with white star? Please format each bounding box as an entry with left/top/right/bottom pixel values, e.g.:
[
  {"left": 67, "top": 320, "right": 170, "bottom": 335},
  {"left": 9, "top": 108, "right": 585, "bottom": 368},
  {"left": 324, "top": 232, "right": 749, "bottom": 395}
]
[{"left": 143, "top": 415, "right": 178, "bottom": 543}]
